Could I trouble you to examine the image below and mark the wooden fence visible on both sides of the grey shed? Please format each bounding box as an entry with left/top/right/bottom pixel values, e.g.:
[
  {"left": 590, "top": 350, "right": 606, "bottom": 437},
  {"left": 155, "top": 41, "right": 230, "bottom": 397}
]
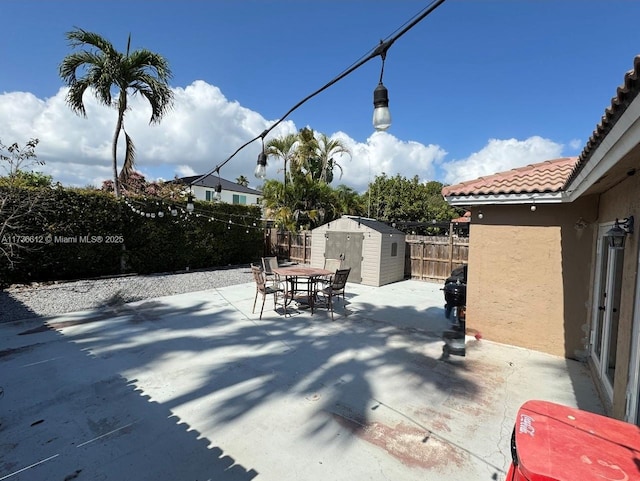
[{"left": 264, "top": 229, "right": 469, "bottom": 282}]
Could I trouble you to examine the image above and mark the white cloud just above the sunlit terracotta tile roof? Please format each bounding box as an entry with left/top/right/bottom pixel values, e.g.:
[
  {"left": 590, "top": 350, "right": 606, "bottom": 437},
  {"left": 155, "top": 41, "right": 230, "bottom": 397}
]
[{"left": 442, "top": 136, "right": 563, "bottom": 184}]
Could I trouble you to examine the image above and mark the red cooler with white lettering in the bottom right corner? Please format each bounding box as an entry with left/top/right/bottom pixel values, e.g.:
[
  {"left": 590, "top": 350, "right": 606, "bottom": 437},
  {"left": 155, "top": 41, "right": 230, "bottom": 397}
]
[{"left": 506, "top": 401, "right": 640, "bottom": 481}]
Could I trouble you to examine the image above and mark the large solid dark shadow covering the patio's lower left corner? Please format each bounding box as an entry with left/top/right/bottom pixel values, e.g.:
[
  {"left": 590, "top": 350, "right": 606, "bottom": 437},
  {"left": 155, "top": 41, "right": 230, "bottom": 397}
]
[{"left": 0, "top": 306, "right": 258, "bottom": 481}]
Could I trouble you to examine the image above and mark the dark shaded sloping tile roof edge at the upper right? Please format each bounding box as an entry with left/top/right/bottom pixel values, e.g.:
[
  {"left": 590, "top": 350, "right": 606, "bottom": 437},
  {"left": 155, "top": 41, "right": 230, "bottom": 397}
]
[{"left": 565, "top": 55, "right": 640, "bottom": 186}]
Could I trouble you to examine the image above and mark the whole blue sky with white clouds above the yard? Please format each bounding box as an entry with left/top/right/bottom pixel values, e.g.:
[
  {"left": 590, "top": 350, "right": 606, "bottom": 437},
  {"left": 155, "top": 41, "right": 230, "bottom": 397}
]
[{"left": 0, "top": 0, "right": 640, "bottom": 191}]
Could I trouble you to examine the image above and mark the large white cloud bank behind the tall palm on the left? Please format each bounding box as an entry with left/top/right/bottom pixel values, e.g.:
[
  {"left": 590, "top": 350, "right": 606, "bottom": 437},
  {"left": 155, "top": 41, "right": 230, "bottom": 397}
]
[{"left": 0, "top": 81, "right": 296, "bottom": 186}]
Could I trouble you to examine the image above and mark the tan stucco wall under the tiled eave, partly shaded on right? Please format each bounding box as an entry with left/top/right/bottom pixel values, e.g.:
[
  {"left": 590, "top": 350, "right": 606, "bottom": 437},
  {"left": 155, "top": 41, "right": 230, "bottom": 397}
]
[{"left": 467, "top": 199, "right": 597, "bottom": 359}]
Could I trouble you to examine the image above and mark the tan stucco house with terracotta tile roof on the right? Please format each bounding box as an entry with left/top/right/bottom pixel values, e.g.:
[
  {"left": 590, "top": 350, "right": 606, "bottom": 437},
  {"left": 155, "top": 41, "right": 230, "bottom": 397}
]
[{"left": 442, "top": 56, "right": 640, "bottom": 424}]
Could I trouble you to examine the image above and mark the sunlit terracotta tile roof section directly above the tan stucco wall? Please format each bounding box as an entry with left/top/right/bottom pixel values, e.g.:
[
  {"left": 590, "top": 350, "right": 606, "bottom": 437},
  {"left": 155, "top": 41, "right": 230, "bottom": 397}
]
[{"left": 442, "top": 157, "right": 578, "bottom": 197}]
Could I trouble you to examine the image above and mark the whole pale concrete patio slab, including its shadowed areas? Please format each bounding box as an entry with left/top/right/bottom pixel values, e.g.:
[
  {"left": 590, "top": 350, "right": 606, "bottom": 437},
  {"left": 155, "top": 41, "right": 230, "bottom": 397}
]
[{"left": 0, "top": 281, "right": 603, "bottom": 481}]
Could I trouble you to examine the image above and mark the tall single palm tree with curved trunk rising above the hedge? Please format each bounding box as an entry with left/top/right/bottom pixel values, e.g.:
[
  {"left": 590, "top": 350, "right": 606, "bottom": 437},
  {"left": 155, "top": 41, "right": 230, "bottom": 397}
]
[{"left": 59, "top": 28, "right": 173, "bottom": 197}]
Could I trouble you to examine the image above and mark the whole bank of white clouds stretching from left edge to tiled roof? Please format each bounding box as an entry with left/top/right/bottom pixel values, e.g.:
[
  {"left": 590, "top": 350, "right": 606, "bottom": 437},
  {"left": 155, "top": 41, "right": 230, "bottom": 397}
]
[{"left": 0, "top": 81, "right": 576, "bottom": 192}]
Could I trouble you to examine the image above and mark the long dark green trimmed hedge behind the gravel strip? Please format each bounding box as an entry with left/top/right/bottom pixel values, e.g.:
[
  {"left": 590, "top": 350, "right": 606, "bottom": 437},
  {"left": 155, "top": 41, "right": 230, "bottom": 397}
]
[{"left": 0, "top": 187, "right": 263, "bottom": 286}]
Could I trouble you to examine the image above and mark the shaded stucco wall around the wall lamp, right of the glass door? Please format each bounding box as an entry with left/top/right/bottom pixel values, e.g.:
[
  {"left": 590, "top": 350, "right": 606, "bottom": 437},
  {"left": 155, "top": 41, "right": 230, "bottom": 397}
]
[{"left": 599, "top": 174, "right": 640, "bottom": 419}]
